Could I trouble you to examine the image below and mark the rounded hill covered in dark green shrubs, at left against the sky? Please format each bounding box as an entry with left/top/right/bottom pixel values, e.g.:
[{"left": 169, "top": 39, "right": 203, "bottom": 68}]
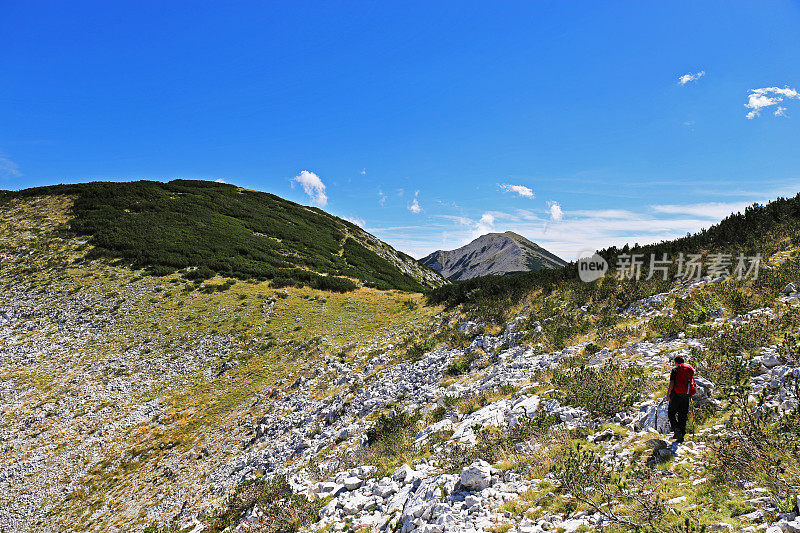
[{"left": 0, "top": 180, "right": 443, "bottom": 292}]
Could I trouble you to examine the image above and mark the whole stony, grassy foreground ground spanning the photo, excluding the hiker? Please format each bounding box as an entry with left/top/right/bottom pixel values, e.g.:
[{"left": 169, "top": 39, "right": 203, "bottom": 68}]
[{"left": 0, "top": 196, "right": 800, "bottom": 533}]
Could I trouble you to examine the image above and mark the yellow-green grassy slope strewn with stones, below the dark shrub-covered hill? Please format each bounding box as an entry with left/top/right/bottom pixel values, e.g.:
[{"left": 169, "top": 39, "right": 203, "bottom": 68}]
[{"left": 0, "top": 195, "right": 446, "bottom": 531}]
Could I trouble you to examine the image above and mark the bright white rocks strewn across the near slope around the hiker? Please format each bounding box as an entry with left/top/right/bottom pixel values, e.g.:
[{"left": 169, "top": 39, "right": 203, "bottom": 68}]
[{"left": 222, "top": 304, "right": 800, "bottom": 532}]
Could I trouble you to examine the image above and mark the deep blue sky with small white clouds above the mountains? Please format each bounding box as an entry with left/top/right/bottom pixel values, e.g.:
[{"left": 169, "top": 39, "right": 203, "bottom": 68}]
[{"left": 0, "top": 0, "right": 800, "bottom": 259}]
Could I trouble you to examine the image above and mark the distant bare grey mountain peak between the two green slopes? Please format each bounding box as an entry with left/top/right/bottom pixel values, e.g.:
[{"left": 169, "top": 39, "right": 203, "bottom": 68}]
[{"left": 420, "top": 231, "right": 566, "bottom": 280}]
